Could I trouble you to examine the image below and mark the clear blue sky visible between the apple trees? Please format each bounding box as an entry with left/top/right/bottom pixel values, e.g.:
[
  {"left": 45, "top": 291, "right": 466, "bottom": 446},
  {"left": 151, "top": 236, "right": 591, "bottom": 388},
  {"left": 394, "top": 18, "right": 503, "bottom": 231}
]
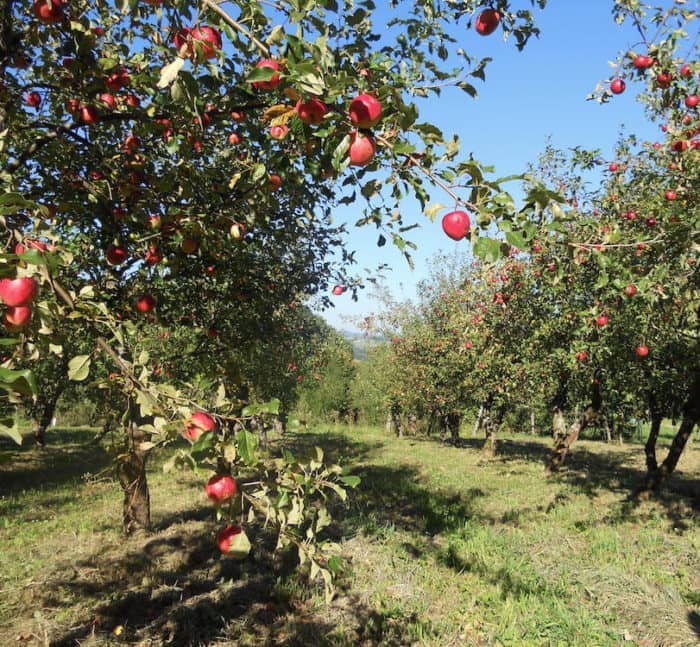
[{"left": 322, "top": 0, "right": 658, "bottom": 330}]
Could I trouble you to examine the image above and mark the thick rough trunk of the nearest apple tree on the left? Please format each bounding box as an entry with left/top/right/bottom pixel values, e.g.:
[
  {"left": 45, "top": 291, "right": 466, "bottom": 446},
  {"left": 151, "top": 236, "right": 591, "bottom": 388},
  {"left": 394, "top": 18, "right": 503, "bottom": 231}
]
[{"left": 117, "top": 402, "right": 151, "bottom": 535}]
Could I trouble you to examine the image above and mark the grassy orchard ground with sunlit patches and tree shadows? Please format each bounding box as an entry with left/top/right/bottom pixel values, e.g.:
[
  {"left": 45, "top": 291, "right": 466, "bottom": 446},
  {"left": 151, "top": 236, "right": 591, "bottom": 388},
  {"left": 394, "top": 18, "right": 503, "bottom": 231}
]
[{"left": 0, "top": 427, "right": 700, "bottom": 647}]
